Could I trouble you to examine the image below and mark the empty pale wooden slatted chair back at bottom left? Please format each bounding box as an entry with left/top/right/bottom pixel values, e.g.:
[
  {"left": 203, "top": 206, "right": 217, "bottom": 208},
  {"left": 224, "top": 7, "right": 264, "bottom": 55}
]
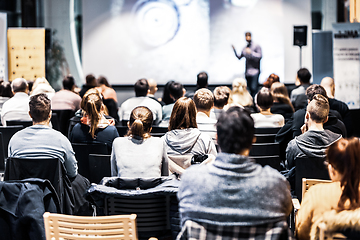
[{"left": 43, "top": 212, "right": 137, "bottom": 240}]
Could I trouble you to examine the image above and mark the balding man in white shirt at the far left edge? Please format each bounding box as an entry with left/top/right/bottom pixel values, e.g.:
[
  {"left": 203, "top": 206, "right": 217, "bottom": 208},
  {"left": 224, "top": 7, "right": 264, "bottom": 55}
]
[{"left": 1, "top": 78, "right": 31, "bottom": 126}]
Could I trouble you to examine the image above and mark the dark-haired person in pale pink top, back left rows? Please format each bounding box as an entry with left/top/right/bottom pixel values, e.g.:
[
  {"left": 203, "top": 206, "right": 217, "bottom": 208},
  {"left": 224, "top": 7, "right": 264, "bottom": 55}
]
[{"left": 51, "top": 75, "right": 81, "bottom": 111}]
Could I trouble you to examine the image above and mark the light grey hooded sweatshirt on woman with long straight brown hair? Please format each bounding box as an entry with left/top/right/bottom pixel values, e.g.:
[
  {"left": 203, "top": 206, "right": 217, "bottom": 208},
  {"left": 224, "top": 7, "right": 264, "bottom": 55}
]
[{"left": 162, "top": 128, "right": 217, "bottom": 172}]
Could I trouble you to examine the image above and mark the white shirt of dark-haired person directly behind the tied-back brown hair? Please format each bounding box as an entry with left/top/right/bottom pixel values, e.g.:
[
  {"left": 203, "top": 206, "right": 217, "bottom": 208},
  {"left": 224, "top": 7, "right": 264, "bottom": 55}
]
[{"left": 119, "top": 97, "right": 162, "bottom": 124}]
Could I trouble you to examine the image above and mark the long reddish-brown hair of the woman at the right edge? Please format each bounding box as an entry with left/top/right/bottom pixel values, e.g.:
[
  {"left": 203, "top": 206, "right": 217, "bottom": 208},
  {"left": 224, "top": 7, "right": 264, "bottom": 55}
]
[{"left": 326, "top": 138, "right": 360, "bottom": 211}]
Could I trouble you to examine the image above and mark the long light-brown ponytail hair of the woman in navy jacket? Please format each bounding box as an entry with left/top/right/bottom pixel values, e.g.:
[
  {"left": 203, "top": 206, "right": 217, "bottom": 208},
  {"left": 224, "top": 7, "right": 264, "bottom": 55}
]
[{"left": 81, "top": 89, "right": 104, "bottom": 138}]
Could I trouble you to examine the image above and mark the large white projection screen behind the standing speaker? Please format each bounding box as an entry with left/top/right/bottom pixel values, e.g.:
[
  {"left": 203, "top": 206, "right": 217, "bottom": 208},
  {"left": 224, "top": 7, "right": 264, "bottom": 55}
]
[{"left": 82, "top": 0, "right": 311, "bottom": 84}]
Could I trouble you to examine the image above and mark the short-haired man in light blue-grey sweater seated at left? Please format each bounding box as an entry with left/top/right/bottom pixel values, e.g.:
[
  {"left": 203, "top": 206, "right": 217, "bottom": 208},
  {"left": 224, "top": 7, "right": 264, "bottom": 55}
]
[{"left": 8, "top": 93, "right": 90, "bottom": 213}]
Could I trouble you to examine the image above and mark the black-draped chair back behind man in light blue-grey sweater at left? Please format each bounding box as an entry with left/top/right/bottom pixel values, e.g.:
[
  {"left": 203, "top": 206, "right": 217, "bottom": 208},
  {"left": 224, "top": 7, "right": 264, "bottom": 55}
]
[{"left": 4, "top": 158, "right": 74, "bottom": 214}]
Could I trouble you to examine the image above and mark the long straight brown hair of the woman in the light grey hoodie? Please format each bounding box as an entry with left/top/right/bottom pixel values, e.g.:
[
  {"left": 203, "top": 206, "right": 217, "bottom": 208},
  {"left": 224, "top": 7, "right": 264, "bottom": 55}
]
[{"left": 169, "top": 97, "right": 197, "bottom": 131}]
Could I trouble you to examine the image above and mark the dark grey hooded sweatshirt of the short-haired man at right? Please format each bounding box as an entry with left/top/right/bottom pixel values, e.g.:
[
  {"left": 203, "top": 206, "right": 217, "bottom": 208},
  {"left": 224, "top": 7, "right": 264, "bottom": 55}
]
[{"left": 286, "top": 129, "right": 342, "bottom": 169}]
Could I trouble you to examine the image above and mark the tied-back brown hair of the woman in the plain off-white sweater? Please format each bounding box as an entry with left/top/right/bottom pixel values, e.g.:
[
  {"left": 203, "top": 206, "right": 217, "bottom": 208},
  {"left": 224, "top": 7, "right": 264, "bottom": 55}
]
[{"left": 127, "top": 106, "right": 153, "bottom": 139}]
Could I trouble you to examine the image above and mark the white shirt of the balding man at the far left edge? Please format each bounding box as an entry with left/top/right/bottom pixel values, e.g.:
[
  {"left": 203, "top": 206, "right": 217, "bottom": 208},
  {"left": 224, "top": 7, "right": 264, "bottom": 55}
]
[{"left": 1, "top": 92, "right": 32, "bottom": 126}]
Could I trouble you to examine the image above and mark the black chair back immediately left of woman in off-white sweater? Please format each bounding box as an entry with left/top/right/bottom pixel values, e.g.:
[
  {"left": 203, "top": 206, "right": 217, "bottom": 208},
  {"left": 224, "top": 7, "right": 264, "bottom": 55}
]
[{"left": 88, "top": 154, "right": 111, "bottom": 183}]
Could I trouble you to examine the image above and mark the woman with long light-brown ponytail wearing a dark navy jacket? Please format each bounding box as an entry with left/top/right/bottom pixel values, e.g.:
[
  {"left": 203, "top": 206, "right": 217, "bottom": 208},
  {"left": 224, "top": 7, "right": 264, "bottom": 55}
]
[{"left": 69, "top": 89, "right": 119, "bottom": 150}]
